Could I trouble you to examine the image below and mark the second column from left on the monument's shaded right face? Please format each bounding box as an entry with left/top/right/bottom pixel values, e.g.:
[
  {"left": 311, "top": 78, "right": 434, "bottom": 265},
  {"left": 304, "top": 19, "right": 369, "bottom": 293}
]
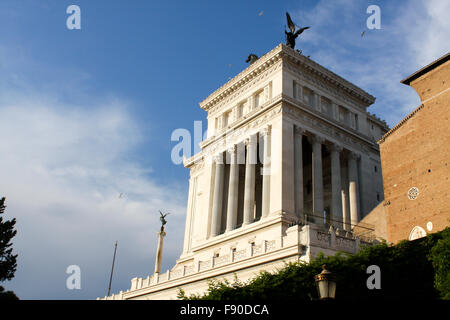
[{"left": 311, "top": 136, "right": 324, "bottom": 221}]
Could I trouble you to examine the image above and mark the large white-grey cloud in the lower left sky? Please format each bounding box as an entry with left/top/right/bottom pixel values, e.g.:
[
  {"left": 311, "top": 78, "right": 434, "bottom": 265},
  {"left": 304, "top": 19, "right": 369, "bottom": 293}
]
[{"left": 0, "top": 90, "right": 186, "bottom": 298}]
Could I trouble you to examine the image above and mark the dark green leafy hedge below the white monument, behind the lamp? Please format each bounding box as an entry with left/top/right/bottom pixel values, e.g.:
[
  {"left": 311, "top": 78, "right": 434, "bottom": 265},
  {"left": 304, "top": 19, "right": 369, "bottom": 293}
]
[{"left": 178, "top": 228, "right": 450, "bottom": 301}]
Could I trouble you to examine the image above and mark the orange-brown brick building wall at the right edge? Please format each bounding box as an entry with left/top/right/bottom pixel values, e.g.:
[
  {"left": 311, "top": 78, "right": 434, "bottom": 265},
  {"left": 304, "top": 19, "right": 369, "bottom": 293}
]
[{"left": 379, "top": 54, "right": 450, "bottom": 243}]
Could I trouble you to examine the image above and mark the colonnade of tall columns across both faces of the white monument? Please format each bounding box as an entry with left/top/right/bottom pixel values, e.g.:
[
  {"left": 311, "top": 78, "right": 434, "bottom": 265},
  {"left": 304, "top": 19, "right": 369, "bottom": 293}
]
[{"left": 210, "top": 126, "right": 359, "bottom": 237}]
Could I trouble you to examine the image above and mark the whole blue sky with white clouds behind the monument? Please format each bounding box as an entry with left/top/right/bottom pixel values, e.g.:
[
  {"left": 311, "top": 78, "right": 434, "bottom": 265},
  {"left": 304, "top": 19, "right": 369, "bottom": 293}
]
[{"left": 0, "top": 0, "right": 450, "bottom": 299}]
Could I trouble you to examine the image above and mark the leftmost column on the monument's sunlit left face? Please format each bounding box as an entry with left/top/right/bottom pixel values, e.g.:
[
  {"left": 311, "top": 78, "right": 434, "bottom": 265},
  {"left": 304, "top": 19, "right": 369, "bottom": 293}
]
[{"left": 211, "top": 154, "right": 225, "bottom": 237}]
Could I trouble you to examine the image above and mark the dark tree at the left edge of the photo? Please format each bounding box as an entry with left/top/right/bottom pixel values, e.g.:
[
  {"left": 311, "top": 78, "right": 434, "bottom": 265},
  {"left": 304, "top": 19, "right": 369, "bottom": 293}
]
[{"left": 0, "top": 197, "right": 17, "bottom": 299}]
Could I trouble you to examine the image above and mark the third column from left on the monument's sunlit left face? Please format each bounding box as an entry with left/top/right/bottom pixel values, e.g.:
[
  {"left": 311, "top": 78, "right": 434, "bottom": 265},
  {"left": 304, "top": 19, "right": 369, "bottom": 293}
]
[{"left": 242, "top": 135, "right": 257, "bottom": 225}]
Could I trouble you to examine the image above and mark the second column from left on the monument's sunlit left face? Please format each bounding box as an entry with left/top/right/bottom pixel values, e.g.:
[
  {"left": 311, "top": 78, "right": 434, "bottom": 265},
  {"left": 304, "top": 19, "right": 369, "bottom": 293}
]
[{"left": 226, "top": 146, "right": 239, "bottom": 232}]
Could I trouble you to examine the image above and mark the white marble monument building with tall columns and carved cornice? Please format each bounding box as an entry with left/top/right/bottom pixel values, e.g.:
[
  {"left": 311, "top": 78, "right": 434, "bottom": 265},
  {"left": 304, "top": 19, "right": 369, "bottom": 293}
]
[{"left": 100, "top": 45, "right": 388, "bottom": 299}]
